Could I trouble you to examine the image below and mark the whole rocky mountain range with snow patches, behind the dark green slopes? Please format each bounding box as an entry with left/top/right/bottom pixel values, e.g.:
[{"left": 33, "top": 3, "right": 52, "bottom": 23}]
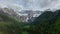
[{"left": 0, "top": 7, "right": 43, "bottom": 22}]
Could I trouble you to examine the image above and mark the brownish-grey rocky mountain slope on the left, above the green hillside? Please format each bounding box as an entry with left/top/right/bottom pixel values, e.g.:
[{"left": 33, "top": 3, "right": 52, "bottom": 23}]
[{"left": 0, "top": 8, "right": 20, "bottom": 20}]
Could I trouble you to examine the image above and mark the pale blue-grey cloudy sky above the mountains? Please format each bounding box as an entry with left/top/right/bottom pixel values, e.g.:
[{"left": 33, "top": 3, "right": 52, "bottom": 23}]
[{"left": 0, "top": 0, "right": 60, "bottom": 10}]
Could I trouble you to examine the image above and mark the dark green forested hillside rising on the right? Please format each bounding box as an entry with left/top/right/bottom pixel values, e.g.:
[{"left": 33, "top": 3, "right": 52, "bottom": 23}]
[{"left": 32, "top": 10, "right": 60, "bottom": 34}]
